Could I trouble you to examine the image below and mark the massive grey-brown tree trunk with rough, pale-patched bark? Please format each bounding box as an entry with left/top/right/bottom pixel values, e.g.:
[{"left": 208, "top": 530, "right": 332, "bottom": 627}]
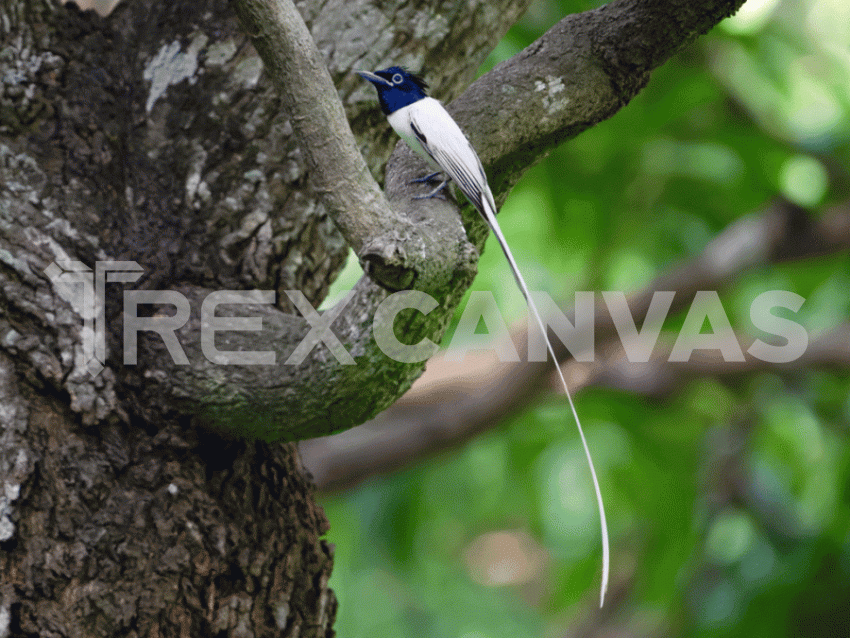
[{"left": 0, "top": 0, "right": 347, "bottom": 636}]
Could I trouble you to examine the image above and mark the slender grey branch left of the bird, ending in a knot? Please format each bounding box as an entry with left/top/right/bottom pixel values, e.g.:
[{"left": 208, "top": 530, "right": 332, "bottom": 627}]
[{"left": 233, "top": 0, "right": 466, "bottom": 292}]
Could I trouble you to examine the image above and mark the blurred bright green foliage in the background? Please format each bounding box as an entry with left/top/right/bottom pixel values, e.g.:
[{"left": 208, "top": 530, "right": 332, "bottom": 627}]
[{"left": 324, "top": 0, "right": 850, "bottom": 638}]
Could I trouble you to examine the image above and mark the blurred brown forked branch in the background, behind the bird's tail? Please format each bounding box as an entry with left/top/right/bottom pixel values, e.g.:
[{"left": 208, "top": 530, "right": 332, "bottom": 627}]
[{"left": 300, "top": 200, "right": 850, "bottom": 491}]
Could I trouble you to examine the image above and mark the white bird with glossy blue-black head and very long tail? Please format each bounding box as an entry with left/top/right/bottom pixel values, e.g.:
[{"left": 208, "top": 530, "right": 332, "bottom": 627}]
[{"left": 357, "top": 66, "right": 610, "bottom": 607}]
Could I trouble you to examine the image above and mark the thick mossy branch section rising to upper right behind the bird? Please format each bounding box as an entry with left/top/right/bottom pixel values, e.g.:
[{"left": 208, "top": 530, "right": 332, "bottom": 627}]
[{"left": 408, "top": 0, "right": 743, "bottom": 220}]
